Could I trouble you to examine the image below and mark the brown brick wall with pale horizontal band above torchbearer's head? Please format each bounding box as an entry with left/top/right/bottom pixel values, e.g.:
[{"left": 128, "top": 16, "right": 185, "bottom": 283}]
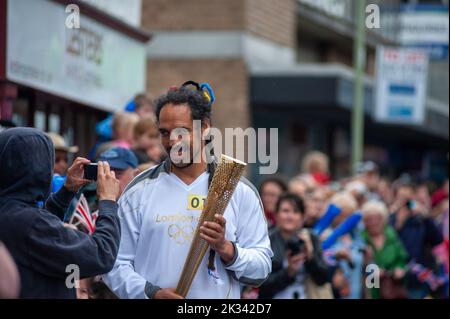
[{"left": 142, "top": 0, "right": 296, "bottom": 135}]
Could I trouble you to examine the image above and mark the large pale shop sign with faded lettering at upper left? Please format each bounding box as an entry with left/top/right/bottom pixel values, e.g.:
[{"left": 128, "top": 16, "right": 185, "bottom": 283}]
[{"left": 6, "top": 0, "right": 146, "bottom": 111}]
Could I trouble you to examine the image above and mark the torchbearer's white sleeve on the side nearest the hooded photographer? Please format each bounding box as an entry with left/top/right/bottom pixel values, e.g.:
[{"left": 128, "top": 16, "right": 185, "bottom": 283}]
[{"left": 104, "top": 198, "right": 147, "bottom": 299}]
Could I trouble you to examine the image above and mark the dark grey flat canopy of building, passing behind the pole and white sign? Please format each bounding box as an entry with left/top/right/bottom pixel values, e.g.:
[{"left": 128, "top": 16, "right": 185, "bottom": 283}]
[{"left": 250, "top": 64, "right": 449, "bottom": 140}]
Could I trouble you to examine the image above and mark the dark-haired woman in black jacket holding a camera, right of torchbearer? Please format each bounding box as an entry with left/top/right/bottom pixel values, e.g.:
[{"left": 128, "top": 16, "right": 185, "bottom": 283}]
[{"left": 259, "top": 194, "right": 331, "bottom": 299}]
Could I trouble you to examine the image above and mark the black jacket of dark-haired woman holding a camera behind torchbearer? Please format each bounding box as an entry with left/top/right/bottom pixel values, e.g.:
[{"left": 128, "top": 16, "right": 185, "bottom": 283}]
[{"left": 259, "top": 228, "right": 328, "bottom": 299}]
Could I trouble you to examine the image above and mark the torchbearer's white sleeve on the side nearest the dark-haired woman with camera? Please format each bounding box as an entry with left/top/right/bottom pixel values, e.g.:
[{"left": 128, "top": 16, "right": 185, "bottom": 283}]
[{"left": 225, "top": 185, "right": 273, "bottom": 286}]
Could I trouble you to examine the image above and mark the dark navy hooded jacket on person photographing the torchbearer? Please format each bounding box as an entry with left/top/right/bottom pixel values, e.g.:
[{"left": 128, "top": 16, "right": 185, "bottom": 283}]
[{"left": 0, "top": 128, "right": 120, "bottom": 298}]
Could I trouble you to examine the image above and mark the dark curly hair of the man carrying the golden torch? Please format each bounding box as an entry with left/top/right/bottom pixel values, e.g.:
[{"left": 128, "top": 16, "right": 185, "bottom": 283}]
[{"left": 156, "top": 86, "right": 211, "bottom": 123}]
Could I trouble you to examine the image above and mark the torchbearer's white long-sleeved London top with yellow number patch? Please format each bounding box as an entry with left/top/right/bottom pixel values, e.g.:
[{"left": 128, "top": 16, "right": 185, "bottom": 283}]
[{"left": 105, "top": 163, "right": 273, "bottom": 299}]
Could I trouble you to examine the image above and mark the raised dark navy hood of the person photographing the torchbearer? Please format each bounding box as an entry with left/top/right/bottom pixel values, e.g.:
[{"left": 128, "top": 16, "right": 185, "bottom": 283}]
[{"left": 0, "top": 127, "right": 55, "bottom": 203}]
